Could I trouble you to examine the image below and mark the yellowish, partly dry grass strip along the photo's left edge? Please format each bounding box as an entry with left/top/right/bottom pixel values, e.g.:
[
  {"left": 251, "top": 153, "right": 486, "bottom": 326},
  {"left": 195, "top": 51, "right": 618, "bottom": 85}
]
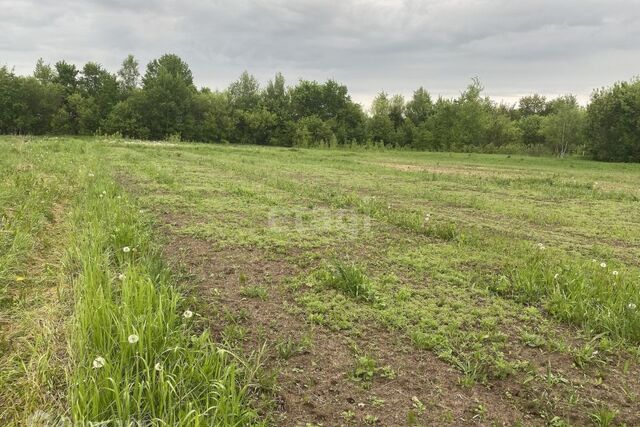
[{"left": 0, "top": 138, "right": 68, "bottom": 425}]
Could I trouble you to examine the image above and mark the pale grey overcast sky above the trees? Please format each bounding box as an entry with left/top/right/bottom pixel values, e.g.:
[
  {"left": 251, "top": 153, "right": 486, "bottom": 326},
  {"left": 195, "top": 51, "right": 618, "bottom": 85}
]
[{"left": 0, "top": 0, "right": 640, "bottom": 106}]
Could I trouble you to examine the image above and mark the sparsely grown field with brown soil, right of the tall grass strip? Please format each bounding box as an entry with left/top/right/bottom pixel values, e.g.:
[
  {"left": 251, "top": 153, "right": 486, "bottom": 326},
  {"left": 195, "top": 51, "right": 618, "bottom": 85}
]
[{"left": 3, "top": 138, "right": 640, "bottom": 426}]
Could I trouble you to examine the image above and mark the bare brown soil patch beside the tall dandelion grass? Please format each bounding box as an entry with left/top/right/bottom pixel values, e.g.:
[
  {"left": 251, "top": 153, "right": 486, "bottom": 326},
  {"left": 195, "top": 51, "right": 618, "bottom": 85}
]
[{"left": 159, "top": 226, "right": 538, "bottom": 426}]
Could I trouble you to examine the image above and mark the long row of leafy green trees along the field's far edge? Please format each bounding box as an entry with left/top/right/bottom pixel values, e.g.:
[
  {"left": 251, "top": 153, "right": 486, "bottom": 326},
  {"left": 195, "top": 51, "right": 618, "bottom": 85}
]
[{"left": 0, "top": 54, "right": 640, "bottom": 162}]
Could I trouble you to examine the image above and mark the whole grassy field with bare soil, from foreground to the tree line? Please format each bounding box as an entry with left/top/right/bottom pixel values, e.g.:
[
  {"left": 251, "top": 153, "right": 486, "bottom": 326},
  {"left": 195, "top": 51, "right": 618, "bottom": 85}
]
[{"left": 0, "top": 137, "right": 640, "bottom": 426}]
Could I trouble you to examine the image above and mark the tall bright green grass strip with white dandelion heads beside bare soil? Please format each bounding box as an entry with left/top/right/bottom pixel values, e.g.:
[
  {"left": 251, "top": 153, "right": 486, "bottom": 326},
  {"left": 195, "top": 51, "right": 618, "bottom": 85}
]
[{"left": 66, "top": 174, "right": 258, "bottom": 426}]
